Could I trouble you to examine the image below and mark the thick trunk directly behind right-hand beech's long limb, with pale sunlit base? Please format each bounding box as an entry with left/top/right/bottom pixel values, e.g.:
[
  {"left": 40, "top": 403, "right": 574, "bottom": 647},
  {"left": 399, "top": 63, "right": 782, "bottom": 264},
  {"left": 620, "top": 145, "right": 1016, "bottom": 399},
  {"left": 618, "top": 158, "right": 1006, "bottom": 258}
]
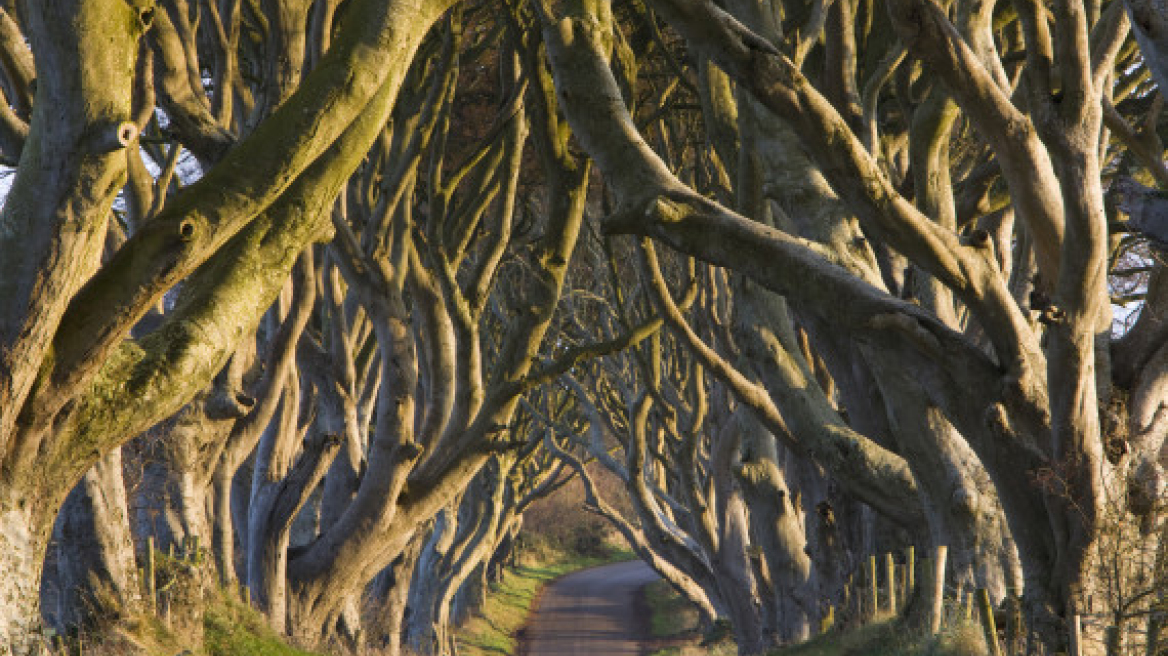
[{"left": 739, "top": 46, "right": 1021, "bottom": 601}]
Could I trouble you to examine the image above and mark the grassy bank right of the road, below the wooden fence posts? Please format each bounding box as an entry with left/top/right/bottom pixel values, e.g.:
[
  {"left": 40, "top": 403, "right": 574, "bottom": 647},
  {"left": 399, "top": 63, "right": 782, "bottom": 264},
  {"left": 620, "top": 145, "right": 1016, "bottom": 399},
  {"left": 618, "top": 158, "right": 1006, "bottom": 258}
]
[{"left": 645, "top": 581, "right": 987, "bottom": 656}]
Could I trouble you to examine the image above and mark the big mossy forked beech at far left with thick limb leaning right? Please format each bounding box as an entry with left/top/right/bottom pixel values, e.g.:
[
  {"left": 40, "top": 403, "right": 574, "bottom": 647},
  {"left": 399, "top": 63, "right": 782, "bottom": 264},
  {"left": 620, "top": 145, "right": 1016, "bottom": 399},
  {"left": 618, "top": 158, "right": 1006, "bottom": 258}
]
[{"left": 0, "top": 0, "right": 449, "bottom": 654}]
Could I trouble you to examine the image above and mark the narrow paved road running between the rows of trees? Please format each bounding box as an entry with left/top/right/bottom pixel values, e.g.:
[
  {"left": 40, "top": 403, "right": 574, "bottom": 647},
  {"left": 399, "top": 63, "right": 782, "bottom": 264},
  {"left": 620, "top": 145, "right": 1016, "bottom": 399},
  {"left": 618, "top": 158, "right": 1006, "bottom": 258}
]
[{"left": 522, "top": 560, "right": 658, "bottom": 656}]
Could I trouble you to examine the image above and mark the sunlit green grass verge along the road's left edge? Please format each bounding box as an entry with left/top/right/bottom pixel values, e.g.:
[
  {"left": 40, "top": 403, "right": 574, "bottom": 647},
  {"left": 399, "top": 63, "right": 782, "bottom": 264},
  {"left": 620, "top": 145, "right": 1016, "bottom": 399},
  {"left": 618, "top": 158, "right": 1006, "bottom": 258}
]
[{"left": 457, "top": 541, "right": 632, "bottom": 656}]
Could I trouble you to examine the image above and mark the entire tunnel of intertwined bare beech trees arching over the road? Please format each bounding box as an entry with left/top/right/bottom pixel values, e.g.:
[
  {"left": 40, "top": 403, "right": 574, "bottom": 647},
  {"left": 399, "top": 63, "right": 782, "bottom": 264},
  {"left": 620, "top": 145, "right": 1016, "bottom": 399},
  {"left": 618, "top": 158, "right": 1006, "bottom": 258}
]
[{"left": 0, "top": 0, "right": 1168, "bottom": 654}]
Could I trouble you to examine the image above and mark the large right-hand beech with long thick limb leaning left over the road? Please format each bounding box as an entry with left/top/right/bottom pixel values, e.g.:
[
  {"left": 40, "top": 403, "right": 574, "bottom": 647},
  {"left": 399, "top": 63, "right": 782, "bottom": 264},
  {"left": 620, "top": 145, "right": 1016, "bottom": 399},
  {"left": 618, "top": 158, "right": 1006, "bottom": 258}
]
[{"left": 534, "top": 1, "right": 1163, "bottom": 650}]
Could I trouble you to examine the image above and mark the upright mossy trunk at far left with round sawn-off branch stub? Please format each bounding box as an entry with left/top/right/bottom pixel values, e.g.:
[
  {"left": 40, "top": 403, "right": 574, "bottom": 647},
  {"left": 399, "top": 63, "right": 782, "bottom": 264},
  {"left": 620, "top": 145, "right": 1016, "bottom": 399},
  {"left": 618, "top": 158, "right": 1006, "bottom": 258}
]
[{"left": 0, "top": 0, "right": 145, "bottom": 655}]
